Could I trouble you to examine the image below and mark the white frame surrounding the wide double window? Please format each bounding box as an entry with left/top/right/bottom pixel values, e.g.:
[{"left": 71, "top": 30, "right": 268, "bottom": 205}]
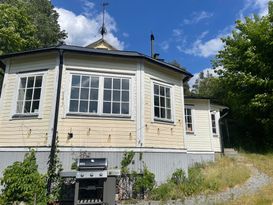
[{"left": 66, "top": 71, "right": 133, "bottom": 119}]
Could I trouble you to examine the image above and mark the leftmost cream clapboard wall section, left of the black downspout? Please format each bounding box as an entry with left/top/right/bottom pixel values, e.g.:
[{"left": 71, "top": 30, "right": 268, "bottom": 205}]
[{"left": 0, "top": 54, "right": 57, "bottom": 147}]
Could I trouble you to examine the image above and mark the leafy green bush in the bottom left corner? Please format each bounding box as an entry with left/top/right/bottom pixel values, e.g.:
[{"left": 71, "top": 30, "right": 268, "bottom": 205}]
[{"left": 0, "top": 150, "right": 46, "bottom": 205}]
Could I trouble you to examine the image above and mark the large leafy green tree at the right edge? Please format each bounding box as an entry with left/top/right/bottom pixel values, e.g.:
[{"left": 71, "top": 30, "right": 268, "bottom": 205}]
[{"left": 214, "top": 1, "right": 273, "bottom": 149}]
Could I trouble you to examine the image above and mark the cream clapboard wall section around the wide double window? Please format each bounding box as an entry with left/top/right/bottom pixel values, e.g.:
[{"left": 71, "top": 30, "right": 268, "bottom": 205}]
[{"left": 58, "top": 54, "right": 137, "bottom": 147}]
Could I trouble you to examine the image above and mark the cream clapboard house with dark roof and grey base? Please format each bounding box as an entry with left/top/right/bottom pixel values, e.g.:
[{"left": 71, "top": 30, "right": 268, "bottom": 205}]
[{"left": 0, "top": 40, "right": 225, "bottom": 183}]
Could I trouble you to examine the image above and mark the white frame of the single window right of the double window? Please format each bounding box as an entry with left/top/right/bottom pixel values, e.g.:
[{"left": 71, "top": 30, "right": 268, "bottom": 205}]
[{"left": 151, "top": 80, "right": 175, "bottom": 123}]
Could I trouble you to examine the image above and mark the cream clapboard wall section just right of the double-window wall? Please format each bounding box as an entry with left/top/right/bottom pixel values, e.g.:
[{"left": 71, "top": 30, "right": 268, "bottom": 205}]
[{"left": 143, "top": 64, "right": 184, "bottom": 148}]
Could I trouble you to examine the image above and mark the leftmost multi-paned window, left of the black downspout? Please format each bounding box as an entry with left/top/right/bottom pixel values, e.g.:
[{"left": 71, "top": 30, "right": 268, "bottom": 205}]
[{"left": 16, "top": 75, "right": 43, "bottom": 114}]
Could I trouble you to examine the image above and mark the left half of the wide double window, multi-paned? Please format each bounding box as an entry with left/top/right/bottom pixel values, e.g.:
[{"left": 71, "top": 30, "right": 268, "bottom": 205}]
[{"left": 69, "top": 75, "right": 99, "bottom": 114}]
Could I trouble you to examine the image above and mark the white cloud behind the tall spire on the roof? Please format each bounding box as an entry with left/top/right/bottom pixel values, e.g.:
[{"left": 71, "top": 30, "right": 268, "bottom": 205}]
[{"left": 55, "top": 6, "right": 124, "bottom": 50}]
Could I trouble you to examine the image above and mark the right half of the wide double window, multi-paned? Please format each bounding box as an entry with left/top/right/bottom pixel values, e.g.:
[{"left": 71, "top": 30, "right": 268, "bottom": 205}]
[{"left": 103, "top": 78, "right": 129, "bottom": 115}]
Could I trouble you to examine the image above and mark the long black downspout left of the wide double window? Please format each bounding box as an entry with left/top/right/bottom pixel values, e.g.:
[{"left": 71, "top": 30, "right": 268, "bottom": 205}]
[{"left": 47, "top": 49, "right": 64, "bottom": 195}]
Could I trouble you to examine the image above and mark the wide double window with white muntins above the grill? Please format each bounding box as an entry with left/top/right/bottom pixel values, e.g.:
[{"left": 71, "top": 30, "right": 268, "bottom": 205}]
[{"left": 69, "top": 74, "right": 130, "bottom": 116}]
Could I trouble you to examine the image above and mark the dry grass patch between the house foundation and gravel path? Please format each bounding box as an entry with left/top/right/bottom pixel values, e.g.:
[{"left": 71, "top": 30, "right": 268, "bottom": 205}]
[{"left": 150, "top": 157, "right": 250, "bottom": 201}]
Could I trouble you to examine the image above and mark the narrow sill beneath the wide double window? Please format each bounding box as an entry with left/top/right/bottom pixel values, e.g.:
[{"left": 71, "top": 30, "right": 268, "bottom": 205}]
[{"left": 66, "top": 113, "right": 131, "bottom": 120}]
